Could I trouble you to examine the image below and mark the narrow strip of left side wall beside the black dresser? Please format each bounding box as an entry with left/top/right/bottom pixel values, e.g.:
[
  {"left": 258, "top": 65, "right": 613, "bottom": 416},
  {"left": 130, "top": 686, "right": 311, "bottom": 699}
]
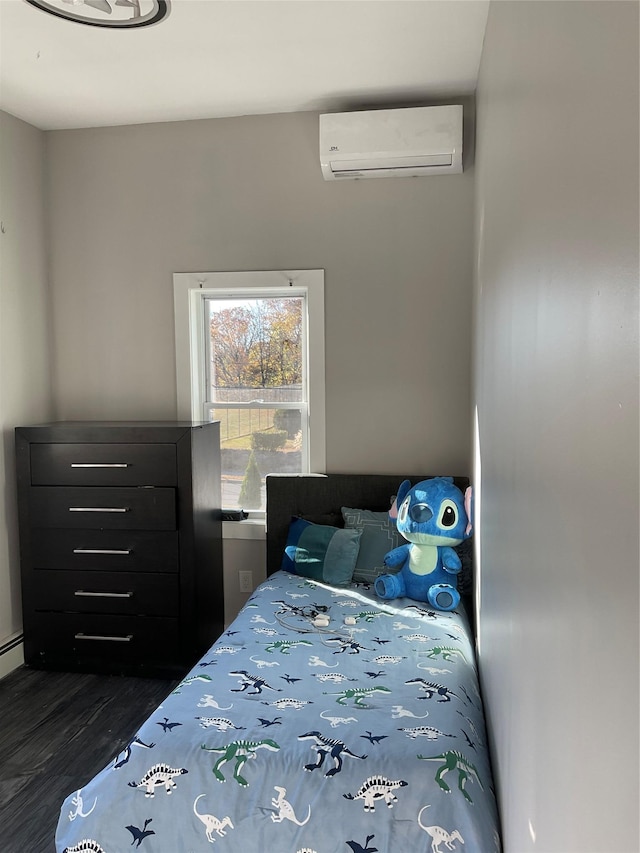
[{"left": 0, "top": 112, "right": 51, "bottom": 676}]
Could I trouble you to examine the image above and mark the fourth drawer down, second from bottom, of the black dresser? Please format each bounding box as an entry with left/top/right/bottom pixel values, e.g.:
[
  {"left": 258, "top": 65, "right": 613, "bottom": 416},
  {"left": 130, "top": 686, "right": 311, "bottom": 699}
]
[{"left": 31, "top": 571, "right": 180, "bottom": 617}]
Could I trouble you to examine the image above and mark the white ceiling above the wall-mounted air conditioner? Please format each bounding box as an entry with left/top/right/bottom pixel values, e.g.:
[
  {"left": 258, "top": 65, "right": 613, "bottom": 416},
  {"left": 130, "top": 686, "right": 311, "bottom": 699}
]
[{"left": 0, "top": 0, "right": 489, "bottom": 130}]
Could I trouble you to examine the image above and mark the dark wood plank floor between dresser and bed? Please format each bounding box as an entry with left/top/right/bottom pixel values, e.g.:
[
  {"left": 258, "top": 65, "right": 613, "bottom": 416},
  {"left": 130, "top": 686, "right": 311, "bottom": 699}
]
[{"left": 0, "top": 667, "right": 177, "bottom": 853}]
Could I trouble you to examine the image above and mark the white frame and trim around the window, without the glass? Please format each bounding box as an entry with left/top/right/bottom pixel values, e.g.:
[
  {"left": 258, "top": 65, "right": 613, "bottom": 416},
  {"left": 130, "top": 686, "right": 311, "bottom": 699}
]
[{"left": 173, "top": 270, "right": 326, "bottom": 515}]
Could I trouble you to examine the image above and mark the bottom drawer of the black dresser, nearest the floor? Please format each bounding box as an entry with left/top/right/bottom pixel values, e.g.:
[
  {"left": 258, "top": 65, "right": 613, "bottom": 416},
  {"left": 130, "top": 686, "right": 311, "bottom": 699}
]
[{"left": 25, "top": 613, "right": 180, "bottom": 667}]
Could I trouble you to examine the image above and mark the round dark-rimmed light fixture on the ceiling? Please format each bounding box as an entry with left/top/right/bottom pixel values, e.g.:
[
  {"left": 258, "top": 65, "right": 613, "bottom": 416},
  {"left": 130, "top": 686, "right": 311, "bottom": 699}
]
[{"left": 25, "top": 0, "right": 169, "bottom": 29}]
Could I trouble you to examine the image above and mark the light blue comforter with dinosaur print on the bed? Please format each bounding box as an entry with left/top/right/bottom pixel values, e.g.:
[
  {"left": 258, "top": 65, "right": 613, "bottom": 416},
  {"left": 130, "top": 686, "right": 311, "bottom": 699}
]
[{"left": 56, "top": 572, "right": 500, "bottom": 853}]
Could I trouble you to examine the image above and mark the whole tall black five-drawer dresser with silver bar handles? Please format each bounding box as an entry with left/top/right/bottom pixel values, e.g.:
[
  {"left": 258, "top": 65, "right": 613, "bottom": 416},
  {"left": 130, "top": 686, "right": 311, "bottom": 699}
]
[{"left": 15, "top": 421, "right": 224, "bottom": 677}]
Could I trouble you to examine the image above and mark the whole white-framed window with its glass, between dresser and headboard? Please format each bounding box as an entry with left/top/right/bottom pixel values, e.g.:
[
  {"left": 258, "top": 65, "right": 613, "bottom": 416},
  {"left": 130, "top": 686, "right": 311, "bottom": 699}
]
[{"left": 174, "top": 270, "right": 325, "bottom": 515}]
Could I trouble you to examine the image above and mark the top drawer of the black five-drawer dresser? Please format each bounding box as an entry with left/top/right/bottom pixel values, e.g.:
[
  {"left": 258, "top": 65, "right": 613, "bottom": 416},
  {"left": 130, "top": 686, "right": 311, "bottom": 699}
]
[{"left": 31, "top": 443, "right": 177, "bottom": 486}]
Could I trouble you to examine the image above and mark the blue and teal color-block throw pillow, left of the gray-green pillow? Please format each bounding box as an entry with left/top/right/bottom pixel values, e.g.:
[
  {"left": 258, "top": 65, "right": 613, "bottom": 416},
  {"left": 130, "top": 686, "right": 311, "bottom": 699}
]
[{"left": 282, "top": 518, "right": 361, "bottom": 586}]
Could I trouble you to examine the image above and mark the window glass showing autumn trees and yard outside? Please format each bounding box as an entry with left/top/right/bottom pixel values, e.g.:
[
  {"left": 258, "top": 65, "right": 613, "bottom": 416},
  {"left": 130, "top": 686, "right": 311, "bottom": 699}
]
[{"left": 206, "top": 296, "right": 307, "bottom": 510}]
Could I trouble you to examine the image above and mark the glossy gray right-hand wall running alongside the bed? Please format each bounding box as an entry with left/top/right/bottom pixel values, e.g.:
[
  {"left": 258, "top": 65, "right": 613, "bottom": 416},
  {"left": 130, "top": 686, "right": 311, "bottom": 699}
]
[{"left": 474, "top": 2, "right": 640, "bottom": 853}]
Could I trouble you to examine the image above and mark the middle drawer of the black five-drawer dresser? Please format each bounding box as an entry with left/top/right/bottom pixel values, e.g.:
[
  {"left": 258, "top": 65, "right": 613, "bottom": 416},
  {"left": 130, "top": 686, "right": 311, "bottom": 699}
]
[{"left": 31, "top": 528, "right": 179, "bottom": 572}]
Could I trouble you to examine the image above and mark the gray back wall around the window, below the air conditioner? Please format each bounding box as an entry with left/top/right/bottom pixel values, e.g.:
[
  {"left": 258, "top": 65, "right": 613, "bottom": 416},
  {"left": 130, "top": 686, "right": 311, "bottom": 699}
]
[{"left": 48, "top": 104, "right": 473, "bottom": 474}]
